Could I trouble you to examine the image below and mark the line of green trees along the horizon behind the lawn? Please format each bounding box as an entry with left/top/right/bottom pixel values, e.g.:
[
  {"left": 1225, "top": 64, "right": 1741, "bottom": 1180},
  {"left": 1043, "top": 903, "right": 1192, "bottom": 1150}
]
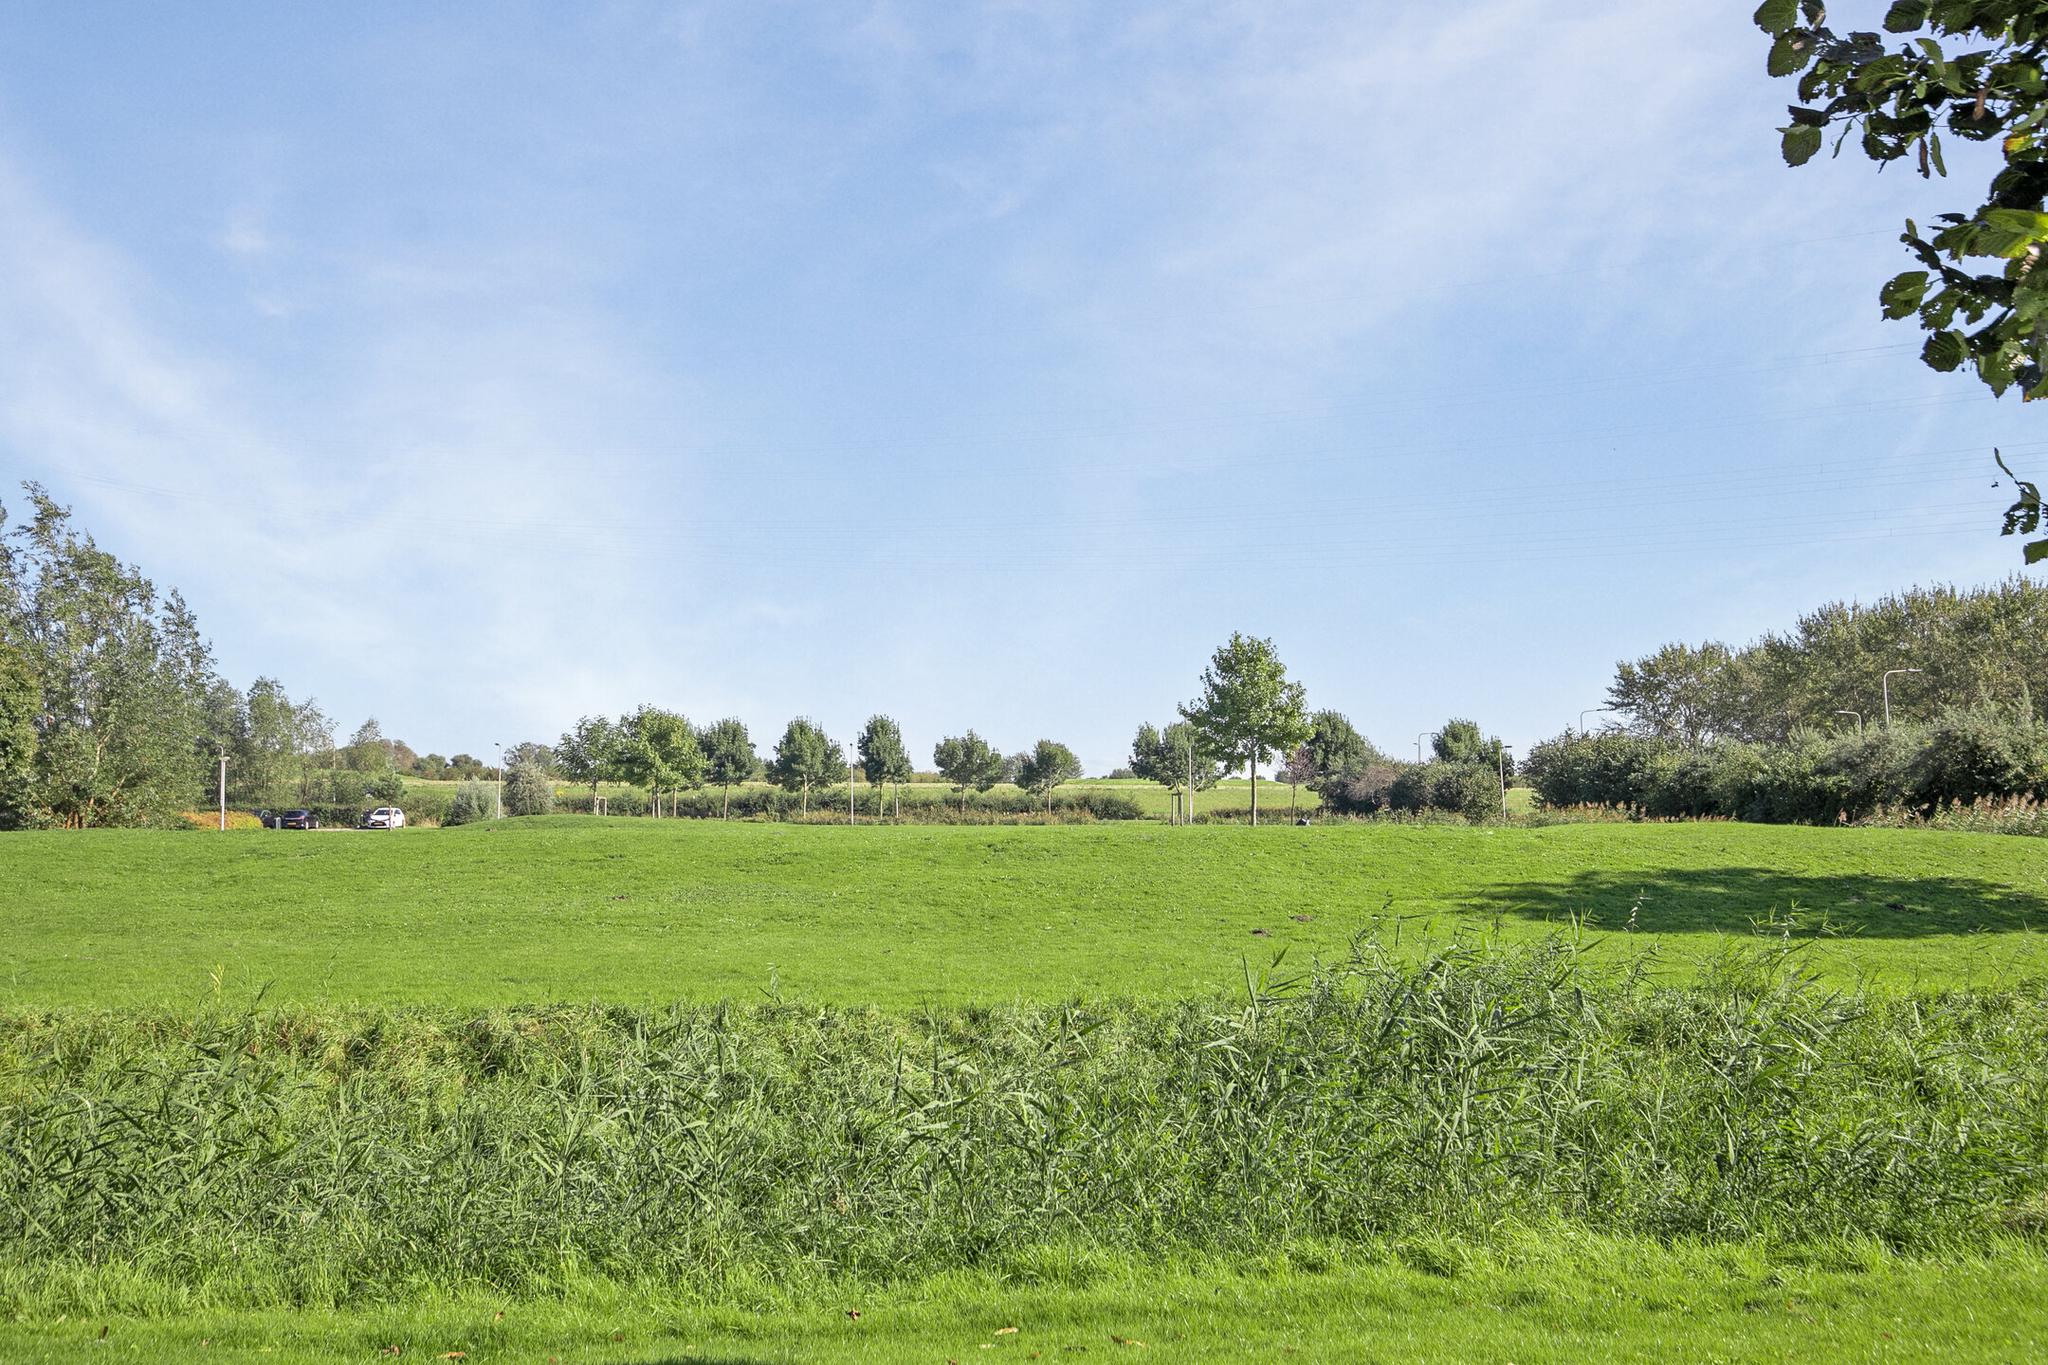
[{"left": 0, "top": 485, "right": 2048, "bottom": 829}]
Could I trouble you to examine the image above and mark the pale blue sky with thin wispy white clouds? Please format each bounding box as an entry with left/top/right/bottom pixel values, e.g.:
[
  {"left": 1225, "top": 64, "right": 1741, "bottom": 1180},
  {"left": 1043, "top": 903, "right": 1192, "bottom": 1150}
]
[{"left": 0, "top": 0, "right": 2048, "bottom": 772}]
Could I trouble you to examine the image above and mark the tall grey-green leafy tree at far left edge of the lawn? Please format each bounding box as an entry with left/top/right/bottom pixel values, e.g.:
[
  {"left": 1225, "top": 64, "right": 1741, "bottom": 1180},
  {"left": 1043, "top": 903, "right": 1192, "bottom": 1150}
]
[{"left": 0, "top": 483, "right": 215, "bottom": 829}]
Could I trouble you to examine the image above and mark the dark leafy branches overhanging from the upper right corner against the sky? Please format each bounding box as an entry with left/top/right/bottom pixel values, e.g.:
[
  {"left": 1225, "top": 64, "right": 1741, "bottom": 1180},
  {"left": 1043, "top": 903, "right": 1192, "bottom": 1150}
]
[{"left": 1755, "top": 0, "right": 2048, "bottom": 563}]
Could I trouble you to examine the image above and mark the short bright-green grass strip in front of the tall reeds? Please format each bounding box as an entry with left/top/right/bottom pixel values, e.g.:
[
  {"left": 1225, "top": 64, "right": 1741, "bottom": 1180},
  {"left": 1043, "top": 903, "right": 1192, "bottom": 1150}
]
[{"left": 0, "top": 1230, "right": 2048, "bottom": 1365}]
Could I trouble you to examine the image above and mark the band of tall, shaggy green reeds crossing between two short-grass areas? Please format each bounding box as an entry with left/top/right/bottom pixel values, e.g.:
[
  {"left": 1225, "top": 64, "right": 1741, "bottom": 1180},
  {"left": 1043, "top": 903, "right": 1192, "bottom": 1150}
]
[{"left": 0, "top": 937, "right": 2048, "bottom": 1312}]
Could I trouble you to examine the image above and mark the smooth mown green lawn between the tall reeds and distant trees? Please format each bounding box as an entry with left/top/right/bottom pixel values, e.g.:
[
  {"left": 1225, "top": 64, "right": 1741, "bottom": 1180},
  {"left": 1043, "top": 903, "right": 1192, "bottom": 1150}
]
[{"left": 0, "top": 817, "right": 2048, "bottom": 1007}]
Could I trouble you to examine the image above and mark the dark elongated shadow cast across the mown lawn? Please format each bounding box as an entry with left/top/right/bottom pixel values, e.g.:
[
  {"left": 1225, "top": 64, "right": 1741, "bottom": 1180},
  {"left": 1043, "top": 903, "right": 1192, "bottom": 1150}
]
[{"left": 1470, "top": 868, "right": 2048, "bottom": 939}]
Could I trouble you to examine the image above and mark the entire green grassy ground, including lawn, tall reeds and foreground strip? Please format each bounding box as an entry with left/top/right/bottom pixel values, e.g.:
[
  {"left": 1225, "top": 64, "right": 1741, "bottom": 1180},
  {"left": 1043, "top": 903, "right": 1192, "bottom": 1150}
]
[{"left": 0, "top": 818, "right": 2048, "bottom": 1365}]
